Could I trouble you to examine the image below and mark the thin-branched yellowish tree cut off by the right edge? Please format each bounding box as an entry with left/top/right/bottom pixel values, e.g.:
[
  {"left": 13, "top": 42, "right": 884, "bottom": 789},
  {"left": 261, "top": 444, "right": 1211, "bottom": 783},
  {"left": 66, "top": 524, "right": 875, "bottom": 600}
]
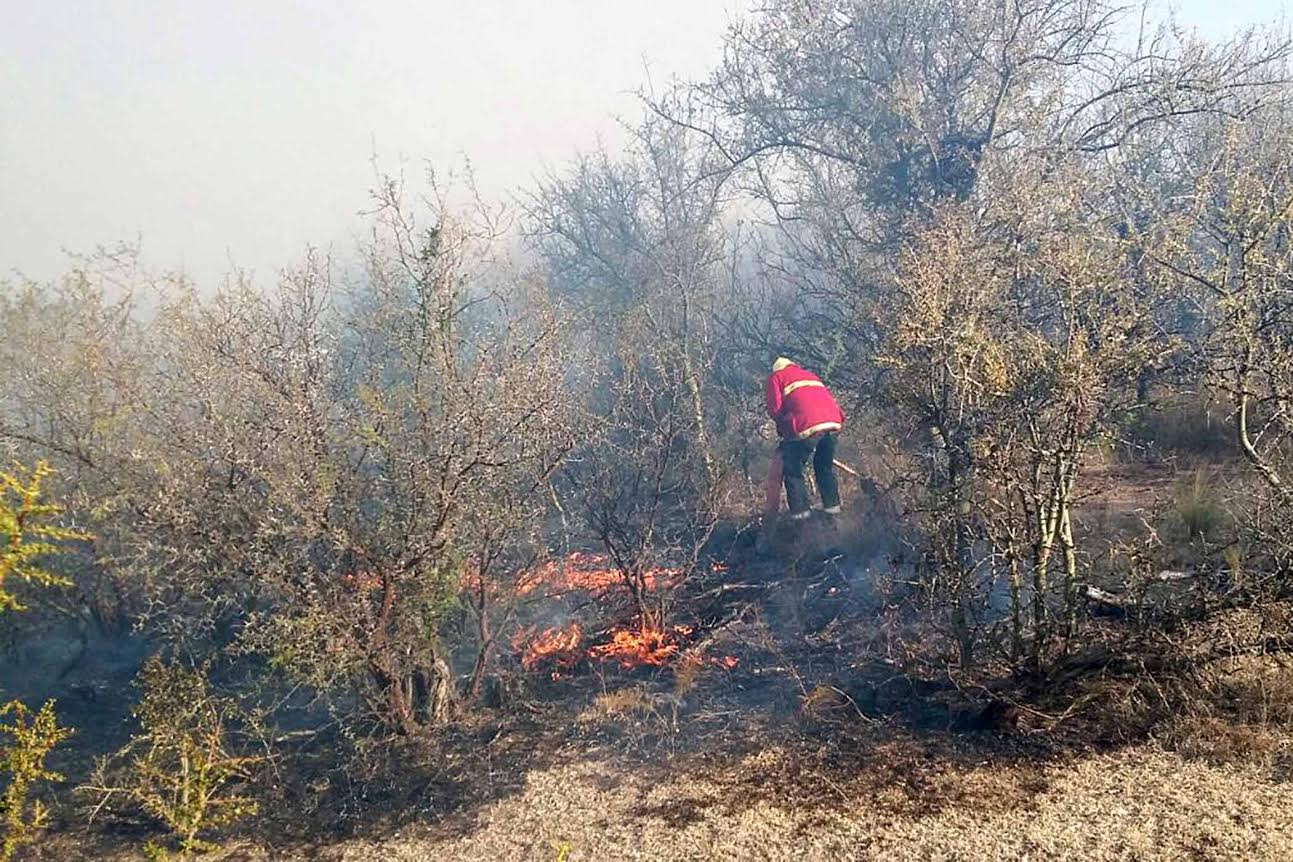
[{"left": 1153, "top": 109, "right": 1293, "bottom": 573}]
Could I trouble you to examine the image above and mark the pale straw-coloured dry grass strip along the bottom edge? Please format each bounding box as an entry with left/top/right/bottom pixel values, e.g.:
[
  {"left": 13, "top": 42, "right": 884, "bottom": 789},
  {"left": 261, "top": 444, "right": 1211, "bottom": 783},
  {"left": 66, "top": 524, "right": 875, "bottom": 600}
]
[{"left": 297, "top": 747, "right": 1293, "bottom": 862}]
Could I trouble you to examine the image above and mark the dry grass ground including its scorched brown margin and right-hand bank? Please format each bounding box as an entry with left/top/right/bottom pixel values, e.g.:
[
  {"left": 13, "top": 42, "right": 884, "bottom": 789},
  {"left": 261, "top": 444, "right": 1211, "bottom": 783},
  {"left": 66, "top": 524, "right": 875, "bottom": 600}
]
[{"left": 42, "top": 605, "right": 1293, "bottom": 862}]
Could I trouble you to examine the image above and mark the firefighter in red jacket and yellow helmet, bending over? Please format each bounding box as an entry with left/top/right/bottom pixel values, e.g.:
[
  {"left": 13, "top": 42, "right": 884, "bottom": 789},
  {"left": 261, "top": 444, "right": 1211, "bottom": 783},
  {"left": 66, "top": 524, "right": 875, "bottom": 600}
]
[{"left": 765, "top": 357, "right": 844, "bottom": 521}]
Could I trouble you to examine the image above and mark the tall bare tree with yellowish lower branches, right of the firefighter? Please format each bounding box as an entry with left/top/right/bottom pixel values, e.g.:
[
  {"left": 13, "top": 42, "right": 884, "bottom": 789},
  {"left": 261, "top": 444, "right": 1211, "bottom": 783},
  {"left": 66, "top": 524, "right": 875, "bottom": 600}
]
[{"left": 641, "top": 0, "right": 1289, "bottom": 662}]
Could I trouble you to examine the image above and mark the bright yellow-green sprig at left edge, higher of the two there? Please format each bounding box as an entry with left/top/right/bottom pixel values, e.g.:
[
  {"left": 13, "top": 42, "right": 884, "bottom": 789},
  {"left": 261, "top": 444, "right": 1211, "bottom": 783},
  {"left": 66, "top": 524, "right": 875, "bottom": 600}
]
[{"left": 0, "top": 461, "right": 87, "bottom": 611}]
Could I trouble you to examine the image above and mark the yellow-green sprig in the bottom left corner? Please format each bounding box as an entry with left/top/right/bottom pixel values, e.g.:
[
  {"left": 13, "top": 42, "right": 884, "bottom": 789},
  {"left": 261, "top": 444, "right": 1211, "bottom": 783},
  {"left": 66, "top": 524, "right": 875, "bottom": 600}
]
[{"left": 0, "top": 700, "right": 71, "bottom": 859}]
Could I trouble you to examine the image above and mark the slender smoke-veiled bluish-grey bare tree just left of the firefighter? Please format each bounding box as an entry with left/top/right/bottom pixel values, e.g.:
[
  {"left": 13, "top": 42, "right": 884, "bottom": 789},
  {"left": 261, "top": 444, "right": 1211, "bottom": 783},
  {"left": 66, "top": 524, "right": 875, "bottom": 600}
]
[{"left": 530, "top": 107, "right": 732, "bottom": 625}]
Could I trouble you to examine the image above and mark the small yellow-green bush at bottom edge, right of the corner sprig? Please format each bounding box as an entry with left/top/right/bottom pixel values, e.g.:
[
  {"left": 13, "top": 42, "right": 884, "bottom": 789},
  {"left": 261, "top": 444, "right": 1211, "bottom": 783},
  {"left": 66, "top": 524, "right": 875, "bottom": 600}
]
[{"left": 87, "top": 657, "right": 264, "bottom": 859}]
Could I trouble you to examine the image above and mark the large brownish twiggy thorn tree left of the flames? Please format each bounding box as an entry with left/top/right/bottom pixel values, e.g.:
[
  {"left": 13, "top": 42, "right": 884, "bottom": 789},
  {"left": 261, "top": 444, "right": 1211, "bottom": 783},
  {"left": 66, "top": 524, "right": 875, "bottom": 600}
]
[{"left": 0, "top": 182, "right": 578, "bottom": 734}]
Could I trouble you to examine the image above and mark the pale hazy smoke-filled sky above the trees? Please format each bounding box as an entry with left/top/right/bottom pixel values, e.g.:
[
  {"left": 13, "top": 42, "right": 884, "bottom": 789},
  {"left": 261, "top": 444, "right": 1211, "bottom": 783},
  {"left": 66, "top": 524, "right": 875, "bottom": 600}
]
[{"left": 0, "top": 0, "right": 1285, "bottom": 288}]
